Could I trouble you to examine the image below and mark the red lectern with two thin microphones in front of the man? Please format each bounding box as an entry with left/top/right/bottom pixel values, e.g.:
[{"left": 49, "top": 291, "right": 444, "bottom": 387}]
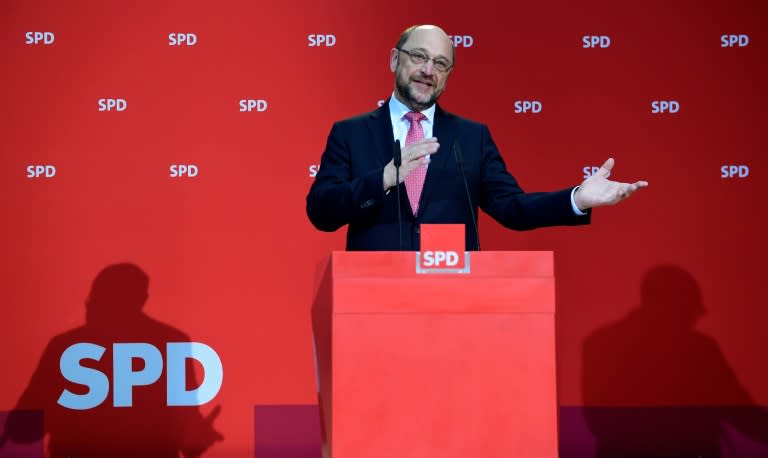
[{"left": 312, "top": 252, "right": 557, "bottom": 458}]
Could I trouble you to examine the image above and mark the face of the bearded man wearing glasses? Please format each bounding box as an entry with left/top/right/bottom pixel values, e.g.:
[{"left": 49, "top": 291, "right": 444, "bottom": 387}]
[{"left": 390, "top": 28, "right": 453, "bottom": 111}]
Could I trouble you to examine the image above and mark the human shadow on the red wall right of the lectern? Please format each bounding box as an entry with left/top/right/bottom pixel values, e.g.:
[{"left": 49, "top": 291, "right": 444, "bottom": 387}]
[{"left": 582, "top": 265, "right": 768, "bottom": 458}]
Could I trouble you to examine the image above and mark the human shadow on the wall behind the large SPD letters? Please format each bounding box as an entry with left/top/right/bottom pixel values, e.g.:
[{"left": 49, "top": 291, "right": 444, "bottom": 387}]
[{"left": 0, "top": 264, "right": 223, "bottom": 458}]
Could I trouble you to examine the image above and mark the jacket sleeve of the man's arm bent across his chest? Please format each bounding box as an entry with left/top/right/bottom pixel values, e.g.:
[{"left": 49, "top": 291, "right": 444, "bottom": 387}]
[{"left": 307, "top": 123, "right": 385, "bottom": 232}]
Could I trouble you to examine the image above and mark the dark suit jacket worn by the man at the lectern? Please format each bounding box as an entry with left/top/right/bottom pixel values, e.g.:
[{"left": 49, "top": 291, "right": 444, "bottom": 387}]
[{"left": 307, "top": 103, "right": 589, "bottom": 251}]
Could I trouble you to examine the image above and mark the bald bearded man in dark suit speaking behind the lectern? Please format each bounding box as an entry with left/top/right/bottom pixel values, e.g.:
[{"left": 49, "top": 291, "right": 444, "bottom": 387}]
[{"left": 307, "top": 25, "right": 648, "bottom": 250}]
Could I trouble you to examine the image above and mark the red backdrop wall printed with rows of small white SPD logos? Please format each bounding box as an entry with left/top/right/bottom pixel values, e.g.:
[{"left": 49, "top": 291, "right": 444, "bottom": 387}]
[{"left": 0, "top": 0, "right": 768, "bottom": 456}]
